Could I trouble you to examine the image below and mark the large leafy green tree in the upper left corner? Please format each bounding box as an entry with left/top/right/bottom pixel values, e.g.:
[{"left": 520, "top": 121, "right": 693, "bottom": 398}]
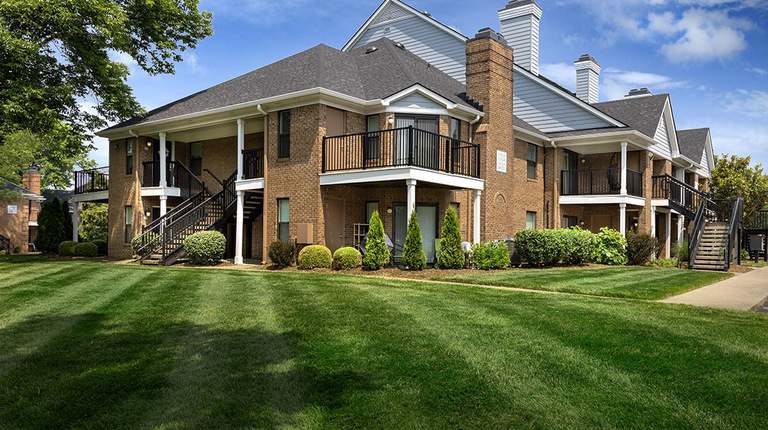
[{"left": 0, "top": 0, "right": 213, "bottom": 186}]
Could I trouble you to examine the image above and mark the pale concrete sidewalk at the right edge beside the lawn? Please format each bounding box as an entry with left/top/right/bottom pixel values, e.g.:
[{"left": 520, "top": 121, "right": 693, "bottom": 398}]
[{"left": 659, "top": 267, "right": 768, "bottom": 311}]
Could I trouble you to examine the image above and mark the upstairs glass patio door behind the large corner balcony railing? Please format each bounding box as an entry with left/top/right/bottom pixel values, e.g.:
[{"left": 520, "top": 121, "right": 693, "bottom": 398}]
[{"left": 395, "top": 115, "right": 440, "bottom": 169}]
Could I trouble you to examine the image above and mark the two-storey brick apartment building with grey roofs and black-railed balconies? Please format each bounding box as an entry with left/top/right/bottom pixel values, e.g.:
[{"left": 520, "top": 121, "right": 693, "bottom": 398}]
[{"left": 78, "top": 0, "right": 712, "bottom": 264}]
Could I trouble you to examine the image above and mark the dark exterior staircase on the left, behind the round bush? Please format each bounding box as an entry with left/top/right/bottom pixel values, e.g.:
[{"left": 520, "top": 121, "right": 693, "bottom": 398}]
[{"left": 133, "top": 165, "right": 263, "bottom": 265}]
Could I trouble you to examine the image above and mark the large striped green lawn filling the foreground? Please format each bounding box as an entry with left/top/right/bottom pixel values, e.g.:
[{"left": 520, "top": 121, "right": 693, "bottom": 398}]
[{"left": 0, "top": 259, "right": 768, "bottom": 429}]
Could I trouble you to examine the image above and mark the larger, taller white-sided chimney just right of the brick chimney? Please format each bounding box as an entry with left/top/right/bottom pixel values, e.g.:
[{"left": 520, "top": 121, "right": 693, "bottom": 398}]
[{"left": 499, "top": 0, "right": 541, "bottom": 75}]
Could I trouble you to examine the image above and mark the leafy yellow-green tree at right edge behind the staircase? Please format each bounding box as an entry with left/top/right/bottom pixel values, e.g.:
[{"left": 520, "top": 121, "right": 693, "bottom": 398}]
[{"left": 710, "top": 154, "right": 768, "bottom": 225}]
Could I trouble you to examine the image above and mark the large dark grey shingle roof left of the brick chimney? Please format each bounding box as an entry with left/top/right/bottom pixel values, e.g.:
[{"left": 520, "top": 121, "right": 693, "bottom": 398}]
[{"left": 107, "top": 39, "right": 470, "bottom": 130}]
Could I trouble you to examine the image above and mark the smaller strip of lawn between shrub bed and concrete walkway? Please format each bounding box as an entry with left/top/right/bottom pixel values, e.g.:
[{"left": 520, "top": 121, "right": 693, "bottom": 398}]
[{"left": 433, "top": 266, "right": 733, "bottom": 300}]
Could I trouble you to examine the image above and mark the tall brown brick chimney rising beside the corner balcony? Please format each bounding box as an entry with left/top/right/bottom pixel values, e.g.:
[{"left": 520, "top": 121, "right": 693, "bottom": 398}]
[{"left": 466, "top": 28, "right": 514, "bottom": 241}]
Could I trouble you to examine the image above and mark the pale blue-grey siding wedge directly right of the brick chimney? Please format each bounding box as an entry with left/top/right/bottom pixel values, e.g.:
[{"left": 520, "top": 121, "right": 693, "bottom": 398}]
[{"left": 512, "top": 73, "right": 611, "bottom": 133}]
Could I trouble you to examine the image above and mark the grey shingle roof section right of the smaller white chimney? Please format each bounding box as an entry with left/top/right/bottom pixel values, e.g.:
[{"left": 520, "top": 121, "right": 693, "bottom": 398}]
[{"left": 592, "top": 94, "right": 669, "bottom": 138}]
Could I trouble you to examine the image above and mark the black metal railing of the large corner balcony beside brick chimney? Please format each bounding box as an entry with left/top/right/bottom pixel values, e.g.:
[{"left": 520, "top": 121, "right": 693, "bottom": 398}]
[{"left": 322, "top": 126, "right": 480, "bottom": 178}]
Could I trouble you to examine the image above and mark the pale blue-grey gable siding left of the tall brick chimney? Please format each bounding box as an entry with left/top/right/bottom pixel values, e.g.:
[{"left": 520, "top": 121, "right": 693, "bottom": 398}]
[{"left": 352, "top": 13, "right": 467, "bottom": 83}]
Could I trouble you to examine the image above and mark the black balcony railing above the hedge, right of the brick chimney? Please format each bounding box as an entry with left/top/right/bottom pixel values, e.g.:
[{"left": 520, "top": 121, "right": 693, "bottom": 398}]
[{"left": 560, "top": 167, "right": 643, "bottom": 197}]
